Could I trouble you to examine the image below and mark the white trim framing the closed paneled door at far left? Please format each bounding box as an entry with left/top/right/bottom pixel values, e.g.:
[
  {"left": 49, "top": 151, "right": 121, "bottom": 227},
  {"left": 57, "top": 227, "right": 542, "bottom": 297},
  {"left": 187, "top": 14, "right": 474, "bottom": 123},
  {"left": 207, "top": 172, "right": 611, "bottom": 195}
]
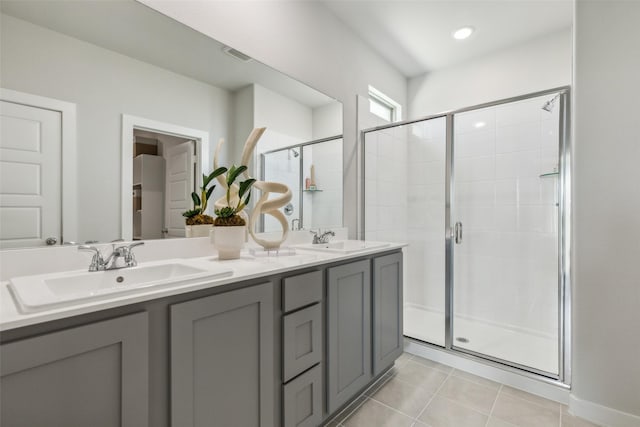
[{"left": 0, "top": 88, "right": 78, "bottom": 244}]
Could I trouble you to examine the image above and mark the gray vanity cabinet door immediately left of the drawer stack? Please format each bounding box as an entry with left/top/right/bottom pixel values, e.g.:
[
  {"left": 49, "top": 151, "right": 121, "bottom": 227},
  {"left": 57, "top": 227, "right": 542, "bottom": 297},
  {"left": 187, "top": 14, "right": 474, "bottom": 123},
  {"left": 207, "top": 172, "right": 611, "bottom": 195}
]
[{"left": 171, "top": 283, "right": 275, "bottom": 427}]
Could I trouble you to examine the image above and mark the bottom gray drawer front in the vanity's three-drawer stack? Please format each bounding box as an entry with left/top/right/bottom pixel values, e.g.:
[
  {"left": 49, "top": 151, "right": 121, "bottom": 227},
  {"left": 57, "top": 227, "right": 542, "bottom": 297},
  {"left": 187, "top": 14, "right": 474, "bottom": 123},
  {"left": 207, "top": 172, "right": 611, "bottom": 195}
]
[{"left": 282, "top": 365, "right": 322, "bottom": 427}]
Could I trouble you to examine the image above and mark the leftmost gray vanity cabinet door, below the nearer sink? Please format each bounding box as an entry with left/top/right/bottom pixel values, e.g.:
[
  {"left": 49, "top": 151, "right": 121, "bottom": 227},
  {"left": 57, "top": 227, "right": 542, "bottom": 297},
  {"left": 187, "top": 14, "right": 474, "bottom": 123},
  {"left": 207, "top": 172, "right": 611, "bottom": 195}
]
[{"left": 0, "top": 313, "right": 149, "bottom": 427}]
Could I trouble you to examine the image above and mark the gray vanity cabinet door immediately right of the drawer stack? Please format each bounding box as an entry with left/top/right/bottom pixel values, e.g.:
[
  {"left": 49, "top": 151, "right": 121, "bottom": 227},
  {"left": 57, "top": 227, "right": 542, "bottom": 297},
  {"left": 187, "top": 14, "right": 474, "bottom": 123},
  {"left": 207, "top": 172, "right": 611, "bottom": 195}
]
[{"left": 326, "top": 260, "right": 372, "bottom": 413}]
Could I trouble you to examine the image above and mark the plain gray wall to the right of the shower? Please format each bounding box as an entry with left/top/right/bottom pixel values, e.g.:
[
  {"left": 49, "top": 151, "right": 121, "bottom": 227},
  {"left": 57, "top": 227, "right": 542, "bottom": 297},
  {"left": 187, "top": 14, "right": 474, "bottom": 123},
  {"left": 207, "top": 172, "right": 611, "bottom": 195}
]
[{"left": 572, "top": 1, "right": 640, "bottom": 425}]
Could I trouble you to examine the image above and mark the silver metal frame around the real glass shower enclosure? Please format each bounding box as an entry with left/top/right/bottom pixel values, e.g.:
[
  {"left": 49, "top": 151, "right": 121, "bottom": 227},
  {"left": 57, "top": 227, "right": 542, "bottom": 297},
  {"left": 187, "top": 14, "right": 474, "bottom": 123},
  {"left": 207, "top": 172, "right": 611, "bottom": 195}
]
[{"left": 358, "top": 86, "right": 572, "bottom": 388}]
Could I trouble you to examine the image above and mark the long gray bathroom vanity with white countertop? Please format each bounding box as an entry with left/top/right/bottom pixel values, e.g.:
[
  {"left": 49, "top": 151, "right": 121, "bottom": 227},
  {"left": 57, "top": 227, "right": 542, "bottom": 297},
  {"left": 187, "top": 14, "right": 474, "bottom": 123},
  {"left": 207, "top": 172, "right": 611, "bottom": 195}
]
[{"left": 0, "top": 245, "right": 403, "bottom": 427}]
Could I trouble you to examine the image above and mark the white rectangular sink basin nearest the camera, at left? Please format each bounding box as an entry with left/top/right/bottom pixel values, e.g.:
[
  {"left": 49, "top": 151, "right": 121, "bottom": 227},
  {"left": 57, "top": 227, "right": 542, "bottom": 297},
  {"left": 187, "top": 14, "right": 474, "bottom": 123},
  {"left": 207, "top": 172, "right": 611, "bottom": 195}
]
[{"left": 9, "top": 261, "right": 233, "bottom": 312}]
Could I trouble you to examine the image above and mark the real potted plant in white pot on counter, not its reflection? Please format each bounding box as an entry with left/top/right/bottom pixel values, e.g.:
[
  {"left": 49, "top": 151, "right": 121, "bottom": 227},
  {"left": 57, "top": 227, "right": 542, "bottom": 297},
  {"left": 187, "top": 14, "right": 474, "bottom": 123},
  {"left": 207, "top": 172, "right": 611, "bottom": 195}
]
[{"left": 212, "top": 165, "right": 256, "bottom": 259}]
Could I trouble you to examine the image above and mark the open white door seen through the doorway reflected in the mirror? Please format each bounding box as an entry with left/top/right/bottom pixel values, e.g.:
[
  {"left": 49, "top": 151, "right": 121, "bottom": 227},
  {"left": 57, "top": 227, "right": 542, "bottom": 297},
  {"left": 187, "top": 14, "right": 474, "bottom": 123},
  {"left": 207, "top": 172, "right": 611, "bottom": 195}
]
[{"left": 164, "top": 141, "right": 195, "bottom": 237}]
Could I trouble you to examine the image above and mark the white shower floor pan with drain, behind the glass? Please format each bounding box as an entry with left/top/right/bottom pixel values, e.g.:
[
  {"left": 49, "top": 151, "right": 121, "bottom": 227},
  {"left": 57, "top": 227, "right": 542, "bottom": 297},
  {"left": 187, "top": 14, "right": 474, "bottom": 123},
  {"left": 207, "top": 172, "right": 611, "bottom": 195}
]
[{"left": 404, "top": 305, "right": 558, "bottom": 374}]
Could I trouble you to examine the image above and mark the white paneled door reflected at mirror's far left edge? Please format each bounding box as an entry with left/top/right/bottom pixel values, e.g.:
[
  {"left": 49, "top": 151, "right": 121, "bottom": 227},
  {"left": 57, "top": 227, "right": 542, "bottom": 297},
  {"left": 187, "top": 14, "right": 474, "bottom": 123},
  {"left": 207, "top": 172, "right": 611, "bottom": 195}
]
[{"left": 0, "top": 101, "right": 62, "bottom": 248}]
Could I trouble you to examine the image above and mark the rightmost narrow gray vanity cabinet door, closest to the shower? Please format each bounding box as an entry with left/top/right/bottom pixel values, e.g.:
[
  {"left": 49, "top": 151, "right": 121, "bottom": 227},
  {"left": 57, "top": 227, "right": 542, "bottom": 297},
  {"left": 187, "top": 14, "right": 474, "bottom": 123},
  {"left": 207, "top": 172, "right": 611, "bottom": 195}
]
[{"left": 373, "top": 252, "right": 404, "bottom": 376}]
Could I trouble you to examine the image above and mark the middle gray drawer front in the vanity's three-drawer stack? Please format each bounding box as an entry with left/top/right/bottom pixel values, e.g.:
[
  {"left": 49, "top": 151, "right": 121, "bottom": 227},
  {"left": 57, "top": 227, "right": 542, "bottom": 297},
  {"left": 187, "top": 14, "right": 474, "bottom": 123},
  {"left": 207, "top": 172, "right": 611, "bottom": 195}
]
[{"left": 282, "top": 304, "right": 322, "bottom": 382}]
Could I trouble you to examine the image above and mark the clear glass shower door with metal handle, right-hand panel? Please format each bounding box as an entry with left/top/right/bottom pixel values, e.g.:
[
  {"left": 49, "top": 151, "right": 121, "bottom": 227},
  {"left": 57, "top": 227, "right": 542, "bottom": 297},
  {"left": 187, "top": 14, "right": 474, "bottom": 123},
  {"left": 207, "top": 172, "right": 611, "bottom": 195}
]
[{"left": 451, "top": 94, "right": 559, "bottom": 375}]
